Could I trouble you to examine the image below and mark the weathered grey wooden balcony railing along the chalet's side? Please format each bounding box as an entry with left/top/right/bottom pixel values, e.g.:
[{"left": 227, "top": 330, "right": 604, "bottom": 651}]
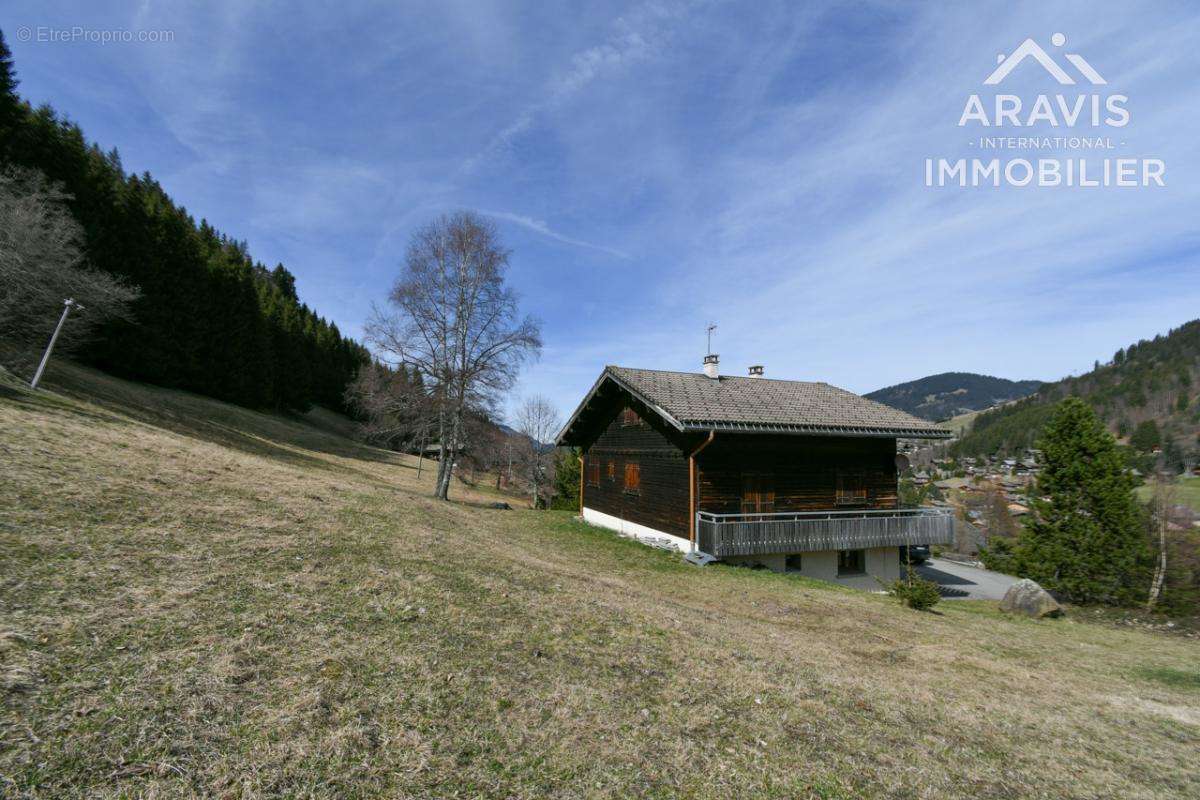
[{"left": 696, "top": 509, "right": 954, "bottom": 558}]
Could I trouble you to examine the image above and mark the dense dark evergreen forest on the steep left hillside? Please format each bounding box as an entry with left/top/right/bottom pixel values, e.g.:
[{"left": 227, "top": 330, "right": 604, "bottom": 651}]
[{"left": 0, "top": 35, "right": 368, "bottom": 409}]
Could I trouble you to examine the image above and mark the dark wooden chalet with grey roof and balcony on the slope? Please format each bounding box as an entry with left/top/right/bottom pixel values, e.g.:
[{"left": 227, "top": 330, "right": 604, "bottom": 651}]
[{"left": 557, "top": 356, "right": 954, "bottom": 589}]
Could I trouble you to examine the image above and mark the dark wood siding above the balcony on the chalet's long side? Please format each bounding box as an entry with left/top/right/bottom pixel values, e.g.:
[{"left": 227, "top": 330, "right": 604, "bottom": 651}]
[{"left": 696, "top": 433, "right": 896, "bottom": 513}]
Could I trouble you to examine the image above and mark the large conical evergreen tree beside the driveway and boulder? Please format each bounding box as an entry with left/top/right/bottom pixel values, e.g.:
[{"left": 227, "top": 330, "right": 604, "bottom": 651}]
[{"left": 1012, "top": 398, "right": 1150, "bottom": 604}]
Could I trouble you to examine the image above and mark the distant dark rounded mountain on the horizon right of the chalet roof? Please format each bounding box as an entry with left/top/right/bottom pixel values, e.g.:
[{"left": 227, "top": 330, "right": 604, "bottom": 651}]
[{"left": 866, "top": 372, "right": 1042, "bottom": 422}]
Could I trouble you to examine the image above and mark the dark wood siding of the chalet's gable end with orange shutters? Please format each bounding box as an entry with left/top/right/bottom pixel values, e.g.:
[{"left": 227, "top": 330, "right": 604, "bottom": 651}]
[{"left": 583, "top": 405, "right": 689, "bottom": 537}]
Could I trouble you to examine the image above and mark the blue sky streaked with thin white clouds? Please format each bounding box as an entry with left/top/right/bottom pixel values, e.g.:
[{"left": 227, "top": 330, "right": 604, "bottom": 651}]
[{"left": 7, "top": 0, "right": 1200, "bottom": 415}]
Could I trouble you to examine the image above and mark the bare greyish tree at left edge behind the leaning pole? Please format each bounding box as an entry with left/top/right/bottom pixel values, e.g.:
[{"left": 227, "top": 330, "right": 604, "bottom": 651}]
[{"left": 0, "top": 167, "right": 138, "bottom": 373}]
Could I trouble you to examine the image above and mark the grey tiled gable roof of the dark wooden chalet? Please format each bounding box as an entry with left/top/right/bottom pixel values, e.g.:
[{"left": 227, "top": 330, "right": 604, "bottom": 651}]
[{"left": 558, "top": 366, "right": 952, "bottom": 444}]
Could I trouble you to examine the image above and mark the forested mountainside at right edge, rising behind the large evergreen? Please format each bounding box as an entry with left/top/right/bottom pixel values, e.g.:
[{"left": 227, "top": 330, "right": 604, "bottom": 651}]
[{"left": 952, "top": 319, "right": 1200, "bottom": 467}]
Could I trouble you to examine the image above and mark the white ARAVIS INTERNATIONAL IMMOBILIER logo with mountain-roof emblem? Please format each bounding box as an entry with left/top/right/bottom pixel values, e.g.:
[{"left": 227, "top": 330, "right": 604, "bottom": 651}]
[{"left": 925, "top": 34, "right": 1166, "bottom": 188}]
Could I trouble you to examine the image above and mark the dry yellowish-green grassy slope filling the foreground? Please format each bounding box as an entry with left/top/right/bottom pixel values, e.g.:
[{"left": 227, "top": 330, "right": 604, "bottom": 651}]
[{"left": 0, "top": 368, "right": 1200, "bottom": 799}]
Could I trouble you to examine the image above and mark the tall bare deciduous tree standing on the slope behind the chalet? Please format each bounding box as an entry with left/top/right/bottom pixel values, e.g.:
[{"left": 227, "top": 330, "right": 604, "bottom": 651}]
[{"left": 367, "top": 212, "right": 541, "bottom": 500}]
